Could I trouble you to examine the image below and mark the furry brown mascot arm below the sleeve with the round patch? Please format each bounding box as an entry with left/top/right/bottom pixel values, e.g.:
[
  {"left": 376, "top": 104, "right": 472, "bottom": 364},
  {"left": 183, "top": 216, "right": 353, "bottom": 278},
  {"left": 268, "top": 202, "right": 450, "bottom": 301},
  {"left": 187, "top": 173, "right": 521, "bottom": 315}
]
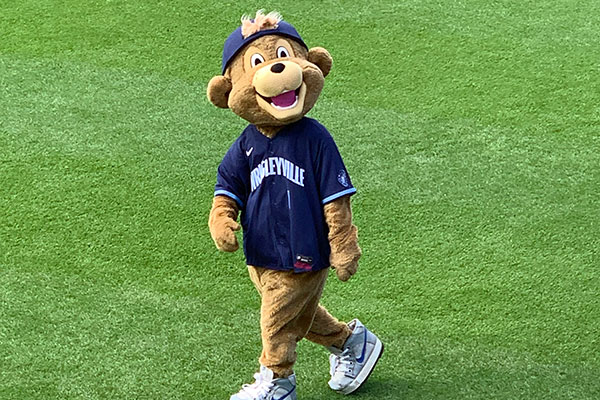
[{"left": 323, "top": 196, "right": 361, "bottom": 281}]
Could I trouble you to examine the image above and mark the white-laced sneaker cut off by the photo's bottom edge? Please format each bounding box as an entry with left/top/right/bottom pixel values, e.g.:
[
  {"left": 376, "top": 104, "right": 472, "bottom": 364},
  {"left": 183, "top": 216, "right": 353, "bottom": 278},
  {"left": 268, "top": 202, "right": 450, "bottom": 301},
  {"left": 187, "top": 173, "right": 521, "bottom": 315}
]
[{"left": 229, "top": 365, "right": 296, "bottom": 400}]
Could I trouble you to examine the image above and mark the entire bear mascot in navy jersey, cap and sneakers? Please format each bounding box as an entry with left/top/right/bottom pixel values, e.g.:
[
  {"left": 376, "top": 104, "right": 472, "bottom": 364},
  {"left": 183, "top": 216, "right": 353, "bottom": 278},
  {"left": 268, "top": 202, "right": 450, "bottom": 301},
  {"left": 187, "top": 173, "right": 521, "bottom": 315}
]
[{"left": 207, "top": 11, "right": 383, "bottom": 400}]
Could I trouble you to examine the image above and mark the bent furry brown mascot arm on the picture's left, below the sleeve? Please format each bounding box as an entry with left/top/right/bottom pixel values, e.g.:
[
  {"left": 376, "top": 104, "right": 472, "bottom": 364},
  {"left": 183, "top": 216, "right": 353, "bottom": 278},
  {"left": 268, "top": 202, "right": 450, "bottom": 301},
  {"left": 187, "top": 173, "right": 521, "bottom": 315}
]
[{"left": 208, "top": 196, "right": 240, "bottom": 252}]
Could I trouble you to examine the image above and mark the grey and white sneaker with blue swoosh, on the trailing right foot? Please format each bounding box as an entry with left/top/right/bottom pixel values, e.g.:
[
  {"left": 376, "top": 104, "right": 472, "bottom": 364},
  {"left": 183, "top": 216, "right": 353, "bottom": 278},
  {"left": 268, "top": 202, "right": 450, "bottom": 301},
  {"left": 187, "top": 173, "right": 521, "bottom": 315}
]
[{"left": 328, "top": 319, "right": 383, "bottom": 394}]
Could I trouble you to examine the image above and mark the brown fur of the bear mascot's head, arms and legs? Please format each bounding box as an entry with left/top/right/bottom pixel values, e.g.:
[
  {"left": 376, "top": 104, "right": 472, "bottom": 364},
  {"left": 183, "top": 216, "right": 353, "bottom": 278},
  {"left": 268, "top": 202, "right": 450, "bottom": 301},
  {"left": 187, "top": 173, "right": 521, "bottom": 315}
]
[{"left": 207, "top": 13, "right": 361, "bottom": 376}]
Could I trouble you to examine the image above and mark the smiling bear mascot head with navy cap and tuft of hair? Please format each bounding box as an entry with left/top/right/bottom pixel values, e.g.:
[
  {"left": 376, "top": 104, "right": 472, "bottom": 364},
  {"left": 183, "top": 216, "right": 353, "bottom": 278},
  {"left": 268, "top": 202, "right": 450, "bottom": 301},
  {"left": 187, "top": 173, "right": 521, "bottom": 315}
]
[{"left": 207, "top": 11, "right": 332, "bottom": 132}]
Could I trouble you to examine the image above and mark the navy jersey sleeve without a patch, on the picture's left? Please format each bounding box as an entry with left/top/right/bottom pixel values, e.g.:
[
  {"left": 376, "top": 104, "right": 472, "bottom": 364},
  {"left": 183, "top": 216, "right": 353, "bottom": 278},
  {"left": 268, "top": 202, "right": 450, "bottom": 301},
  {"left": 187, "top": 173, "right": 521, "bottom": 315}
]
[{"left": 215, "top": 140, "right": 250, "bottom": 208}]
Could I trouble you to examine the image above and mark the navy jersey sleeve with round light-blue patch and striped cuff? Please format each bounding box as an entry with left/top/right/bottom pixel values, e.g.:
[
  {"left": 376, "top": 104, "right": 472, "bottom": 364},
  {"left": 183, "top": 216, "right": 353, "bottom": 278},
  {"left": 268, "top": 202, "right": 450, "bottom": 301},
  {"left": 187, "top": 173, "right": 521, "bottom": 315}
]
[{"left": 316, "top": 134, "right": 356, "bottom": 204}]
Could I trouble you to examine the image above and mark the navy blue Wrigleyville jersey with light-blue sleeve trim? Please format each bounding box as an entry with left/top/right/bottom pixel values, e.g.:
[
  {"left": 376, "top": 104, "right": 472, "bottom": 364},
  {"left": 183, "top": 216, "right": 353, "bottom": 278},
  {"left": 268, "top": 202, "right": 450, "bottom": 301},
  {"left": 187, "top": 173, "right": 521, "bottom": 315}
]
[{"left": 215, "top": 118, "right": 356, "bottom": 272}]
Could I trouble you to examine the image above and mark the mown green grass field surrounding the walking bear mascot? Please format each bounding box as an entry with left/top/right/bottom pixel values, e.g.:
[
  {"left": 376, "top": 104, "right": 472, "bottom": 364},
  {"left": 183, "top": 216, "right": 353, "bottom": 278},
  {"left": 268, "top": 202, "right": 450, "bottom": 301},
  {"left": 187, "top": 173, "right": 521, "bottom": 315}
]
[{"left": 0, "top": 0, "right": 600, "bottom": 400}]
